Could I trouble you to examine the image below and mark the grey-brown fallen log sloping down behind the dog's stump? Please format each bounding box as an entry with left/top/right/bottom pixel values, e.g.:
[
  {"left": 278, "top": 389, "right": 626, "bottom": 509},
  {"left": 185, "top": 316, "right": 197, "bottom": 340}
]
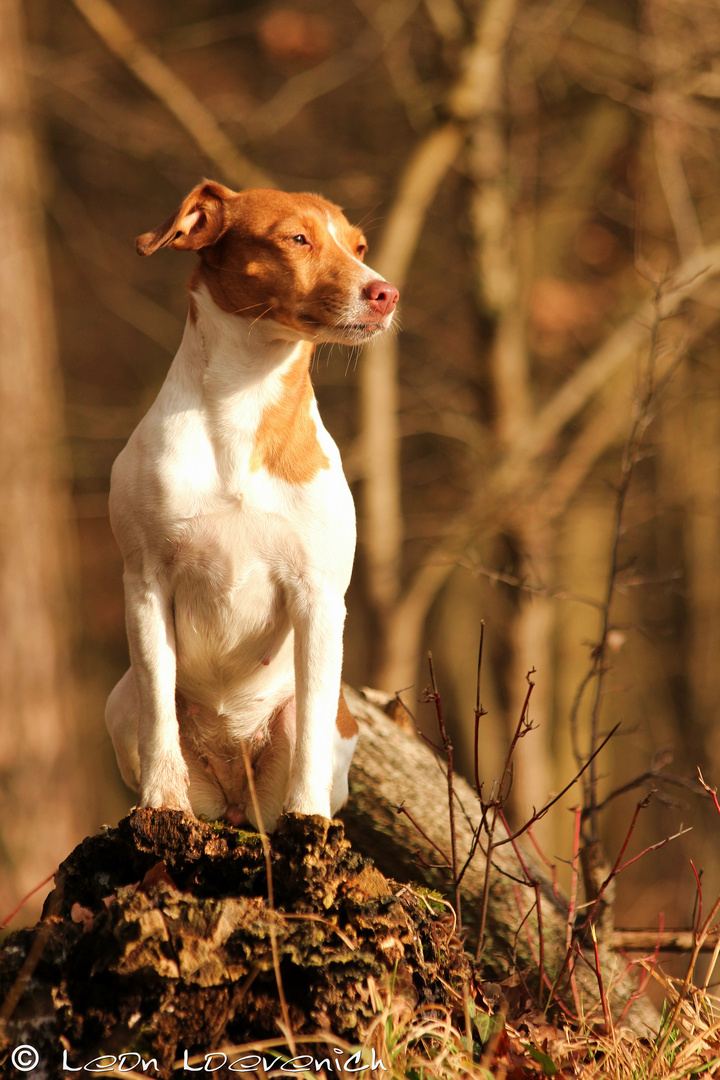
[{"left": 342, "top": 687, "right": 657, "bottom": 1030}]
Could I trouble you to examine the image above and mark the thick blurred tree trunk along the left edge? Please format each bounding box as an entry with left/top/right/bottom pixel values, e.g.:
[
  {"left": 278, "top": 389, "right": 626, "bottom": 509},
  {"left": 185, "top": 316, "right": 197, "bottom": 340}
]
[{"left": 0, "top": 0, "right": 78, "bottom": 917}]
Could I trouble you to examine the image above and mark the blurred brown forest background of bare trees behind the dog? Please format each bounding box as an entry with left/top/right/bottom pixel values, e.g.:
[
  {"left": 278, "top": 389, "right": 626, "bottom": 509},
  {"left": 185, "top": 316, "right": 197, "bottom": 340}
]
[{"left": 0, "top": 0, "right": 720, "bottom": 946}]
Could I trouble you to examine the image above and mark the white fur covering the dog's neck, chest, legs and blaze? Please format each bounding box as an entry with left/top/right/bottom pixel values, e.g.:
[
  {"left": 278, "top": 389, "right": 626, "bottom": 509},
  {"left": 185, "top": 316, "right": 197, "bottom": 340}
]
[{"left": 106, "top": 217, "right": 397, "bottom": 828}]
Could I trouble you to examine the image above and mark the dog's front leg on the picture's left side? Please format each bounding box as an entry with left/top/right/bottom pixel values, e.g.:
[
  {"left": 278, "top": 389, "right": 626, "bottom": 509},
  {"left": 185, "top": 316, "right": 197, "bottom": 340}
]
[{"left": 124, "top": 573, "right": 192, "bottom": 813}]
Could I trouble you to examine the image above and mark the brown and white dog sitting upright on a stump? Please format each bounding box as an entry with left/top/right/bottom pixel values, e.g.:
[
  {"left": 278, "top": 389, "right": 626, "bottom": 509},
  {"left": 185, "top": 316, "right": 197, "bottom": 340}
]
[{"left": 106, "top": 180, "right": 398, "bottom": 831}]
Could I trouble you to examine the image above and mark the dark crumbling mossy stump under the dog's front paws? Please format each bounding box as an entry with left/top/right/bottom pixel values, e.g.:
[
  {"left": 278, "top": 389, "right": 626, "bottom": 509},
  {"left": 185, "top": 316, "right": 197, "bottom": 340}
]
[{"left": 0, "top": 809, "right": 473, "bottom": 1080}]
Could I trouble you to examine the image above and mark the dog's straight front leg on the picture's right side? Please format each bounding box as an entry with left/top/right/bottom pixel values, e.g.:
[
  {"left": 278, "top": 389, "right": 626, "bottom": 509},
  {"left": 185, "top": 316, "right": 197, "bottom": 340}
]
[{"left": 285, "top": 588, "right": 345, "bottom": 818}]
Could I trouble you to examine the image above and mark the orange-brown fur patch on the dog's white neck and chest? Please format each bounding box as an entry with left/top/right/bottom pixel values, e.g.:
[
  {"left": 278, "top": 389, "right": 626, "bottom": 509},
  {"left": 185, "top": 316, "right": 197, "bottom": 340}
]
[{"left": 250, "top": 345, "right": 330, "bottom": 484}]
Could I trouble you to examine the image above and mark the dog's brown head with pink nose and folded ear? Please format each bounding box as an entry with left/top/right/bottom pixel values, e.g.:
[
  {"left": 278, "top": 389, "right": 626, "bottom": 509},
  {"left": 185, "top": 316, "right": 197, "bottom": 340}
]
[{"left": 136, "top": 180, "right": 398, "bottom": 343}]
